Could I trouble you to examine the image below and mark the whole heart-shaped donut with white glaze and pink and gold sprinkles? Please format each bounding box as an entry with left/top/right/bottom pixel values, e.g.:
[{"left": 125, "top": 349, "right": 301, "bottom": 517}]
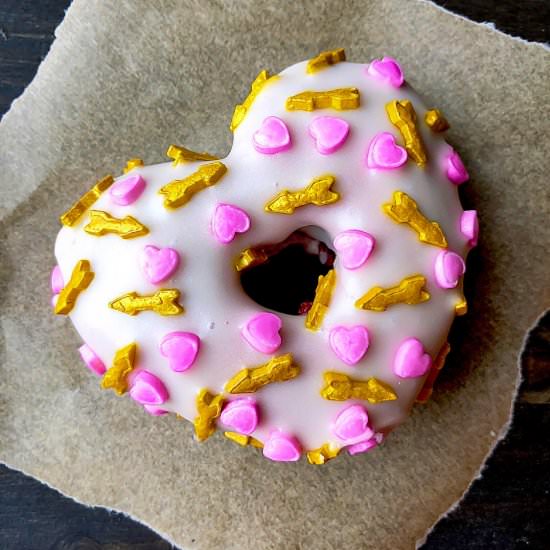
[{"left": 51, "top": 49, "right": 478, "bottom": 464}]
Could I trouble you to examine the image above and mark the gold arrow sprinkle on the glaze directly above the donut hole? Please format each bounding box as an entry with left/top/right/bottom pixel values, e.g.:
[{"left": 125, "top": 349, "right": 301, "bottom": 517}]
[{"left": 264, "top": 175, "right": 340, "bottom": 214}]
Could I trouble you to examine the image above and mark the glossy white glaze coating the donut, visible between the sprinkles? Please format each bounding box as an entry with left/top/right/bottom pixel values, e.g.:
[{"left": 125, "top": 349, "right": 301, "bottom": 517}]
[{"left": 55, "top": 62, "right": 469, "bottom": 458}]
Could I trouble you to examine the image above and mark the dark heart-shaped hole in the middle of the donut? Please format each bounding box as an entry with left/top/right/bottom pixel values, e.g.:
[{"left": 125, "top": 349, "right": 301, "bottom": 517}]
[{"left": 241, "top": 226, "right": 336, "bottom": 315}]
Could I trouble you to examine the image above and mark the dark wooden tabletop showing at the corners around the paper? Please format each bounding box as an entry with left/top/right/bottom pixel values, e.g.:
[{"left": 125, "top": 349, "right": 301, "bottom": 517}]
[{"left": 0, "top": 0, "right": 550, "bottom": 550}]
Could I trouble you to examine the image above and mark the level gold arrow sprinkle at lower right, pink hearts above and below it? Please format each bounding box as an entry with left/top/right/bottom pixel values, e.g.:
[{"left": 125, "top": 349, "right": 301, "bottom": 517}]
[{"left": 321, "top": 372, "right": 397, "bottom": 405}]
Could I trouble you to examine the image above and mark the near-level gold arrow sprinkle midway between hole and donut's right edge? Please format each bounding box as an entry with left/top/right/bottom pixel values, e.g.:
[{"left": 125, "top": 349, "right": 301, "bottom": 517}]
[{"left": 355, "top": 275, "right": 430, "bottom": 311}]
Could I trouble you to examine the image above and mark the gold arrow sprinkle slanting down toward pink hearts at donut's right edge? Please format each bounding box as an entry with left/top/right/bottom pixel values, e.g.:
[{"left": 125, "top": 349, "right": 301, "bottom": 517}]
[{"left": 382, "top": 191, "right": 447, "bottom": 248}]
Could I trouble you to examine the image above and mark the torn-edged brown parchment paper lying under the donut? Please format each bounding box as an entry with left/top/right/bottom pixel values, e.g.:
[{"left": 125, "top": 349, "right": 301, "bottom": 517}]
[{"left": 0, "top": 0, "right": 550, "bottom": 550}]
